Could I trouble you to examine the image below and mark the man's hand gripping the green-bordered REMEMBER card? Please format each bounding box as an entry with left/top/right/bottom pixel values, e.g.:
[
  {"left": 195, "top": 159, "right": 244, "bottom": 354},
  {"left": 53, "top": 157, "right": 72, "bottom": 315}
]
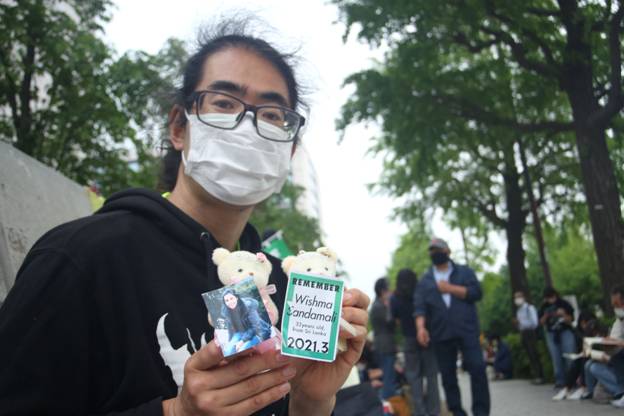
[{"left": 289, "top": 289, "right": 370, "bottom": 416}]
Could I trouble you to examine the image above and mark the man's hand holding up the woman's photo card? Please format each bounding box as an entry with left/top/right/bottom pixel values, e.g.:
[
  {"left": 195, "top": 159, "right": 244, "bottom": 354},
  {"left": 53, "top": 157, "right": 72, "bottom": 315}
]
[{"left": 163, "top": 341, "right": 296, "bottom": 416}]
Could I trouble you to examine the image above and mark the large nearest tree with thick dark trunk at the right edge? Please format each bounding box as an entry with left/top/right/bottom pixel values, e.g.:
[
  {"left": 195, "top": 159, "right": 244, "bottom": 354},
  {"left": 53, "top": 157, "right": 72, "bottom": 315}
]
[{"left": 335, "top": 0, "right": 624, "bottom": 308}]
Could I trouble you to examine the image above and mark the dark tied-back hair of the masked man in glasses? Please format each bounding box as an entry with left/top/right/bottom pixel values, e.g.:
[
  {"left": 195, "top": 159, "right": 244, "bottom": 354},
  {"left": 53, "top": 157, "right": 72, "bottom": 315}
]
[{"left": 158, "top": 15, "right": 308, "bottom": 191}]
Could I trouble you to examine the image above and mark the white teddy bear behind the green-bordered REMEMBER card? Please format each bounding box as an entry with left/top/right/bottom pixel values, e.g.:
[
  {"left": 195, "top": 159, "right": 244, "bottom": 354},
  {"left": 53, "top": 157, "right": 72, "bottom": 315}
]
[{"left": 282, "top": 247, "right": 357, "bottom": 351}]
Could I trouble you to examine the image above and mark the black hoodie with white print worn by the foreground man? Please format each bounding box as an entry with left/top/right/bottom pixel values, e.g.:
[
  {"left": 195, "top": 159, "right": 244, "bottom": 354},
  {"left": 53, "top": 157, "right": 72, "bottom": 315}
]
[{"left": 0, "top": 190, "right": 287, "bottom": 415}]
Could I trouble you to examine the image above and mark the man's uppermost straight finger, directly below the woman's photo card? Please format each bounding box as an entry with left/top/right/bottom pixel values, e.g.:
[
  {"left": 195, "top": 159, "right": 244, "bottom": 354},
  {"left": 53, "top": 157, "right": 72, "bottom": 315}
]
[{"left": 205, "top": 351, "right": 292, "bottom": 388}]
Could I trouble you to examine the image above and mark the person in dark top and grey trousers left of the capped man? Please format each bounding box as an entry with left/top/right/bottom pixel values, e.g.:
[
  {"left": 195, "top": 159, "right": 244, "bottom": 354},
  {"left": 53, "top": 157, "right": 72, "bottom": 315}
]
[{"left": 390, "top": 269, "right": 440, "bottom": 416}]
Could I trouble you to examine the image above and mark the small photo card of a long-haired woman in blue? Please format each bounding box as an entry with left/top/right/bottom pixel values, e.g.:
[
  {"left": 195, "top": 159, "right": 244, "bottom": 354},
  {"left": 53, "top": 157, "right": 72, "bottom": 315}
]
[{"left": 202, "top": 277, "right": 274, "bottom": 357}]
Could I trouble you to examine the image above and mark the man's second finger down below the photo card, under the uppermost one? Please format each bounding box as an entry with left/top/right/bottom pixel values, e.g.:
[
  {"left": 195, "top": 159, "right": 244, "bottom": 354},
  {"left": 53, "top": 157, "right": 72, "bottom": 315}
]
[{"left": 213, "top": 365, "right": 297, "bottom": 407}]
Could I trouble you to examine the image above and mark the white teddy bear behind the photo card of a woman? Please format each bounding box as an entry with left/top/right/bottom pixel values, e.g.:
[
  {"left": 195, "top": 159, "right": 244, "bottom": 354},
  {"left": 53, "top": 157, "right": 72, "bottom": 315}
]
[{"left": 212, "top": 247, "right": 279, "bottom": 325}]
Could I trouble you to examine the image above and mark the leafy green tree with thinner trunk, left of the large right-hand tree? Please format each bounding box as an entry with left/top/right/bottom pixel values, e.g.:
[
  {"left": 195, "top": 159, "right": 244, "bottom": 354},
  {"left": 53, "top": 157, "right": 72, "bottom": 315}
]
[{"left": 338, "top": 32, "right": 577, "bottom": 301}]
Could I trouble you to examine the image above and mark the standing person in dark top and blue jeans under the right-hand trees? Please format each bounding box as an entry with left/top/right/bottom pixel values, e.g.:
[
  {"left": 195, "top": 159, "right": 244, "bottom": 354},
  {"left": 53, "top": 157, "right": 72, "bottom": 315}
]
[{"left": 539, "top": 287, "right": 576, "bottom": 389}]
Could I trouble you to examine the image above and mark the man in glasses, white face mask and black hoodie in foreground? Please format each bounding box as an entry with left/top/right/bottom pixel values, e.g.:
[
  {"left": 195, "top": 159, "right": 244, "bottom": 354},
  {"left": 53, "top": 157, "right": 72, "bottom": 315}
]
[{"left": 0, "top": 18, "right": 369, "bottom": 416}]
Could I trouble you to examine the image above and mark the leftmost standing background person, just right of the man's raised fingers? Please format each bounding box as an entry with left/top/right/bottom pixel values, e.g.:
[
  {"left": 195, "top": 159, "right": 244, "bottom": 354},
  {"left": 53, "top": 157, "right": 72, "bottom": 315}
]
[{"left": 370, "top": 277, "right": 397, "bottom": 400}]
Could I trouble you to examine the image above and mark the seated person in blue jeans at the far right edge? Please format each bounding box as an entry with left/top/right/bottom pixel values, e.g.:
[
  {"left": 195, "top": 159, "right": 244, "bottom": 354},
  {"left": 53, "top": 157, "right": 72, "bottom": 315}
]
[{"left": 583, "top": 285, "right": 624, "bottom": 408}]
